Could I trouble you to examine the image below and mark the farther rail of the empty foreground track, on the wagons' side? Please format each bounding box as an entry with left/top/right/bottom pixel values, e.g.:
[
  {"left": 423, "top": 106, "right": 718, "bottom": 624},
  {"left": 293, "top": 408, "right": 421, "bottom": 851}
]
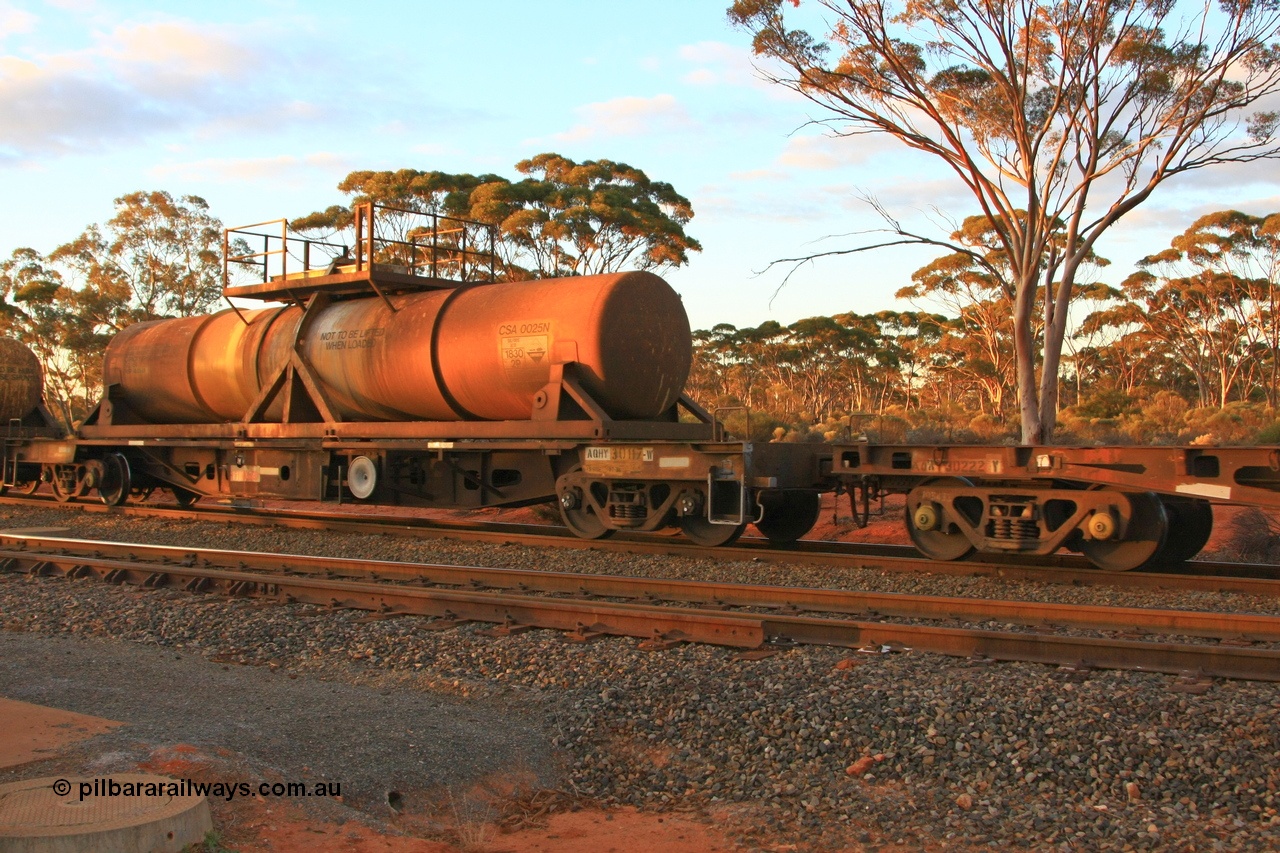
[{"left": 0, "top": 532, "right": 1280, "bottom": 643}]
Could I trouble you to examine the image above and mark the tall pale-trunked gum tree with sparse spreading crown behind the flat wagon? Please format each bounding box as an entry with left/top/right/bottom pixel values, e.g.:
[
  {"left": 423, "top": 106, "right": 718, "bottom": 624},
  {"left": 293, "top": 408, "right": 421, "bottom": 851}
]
[{"left": 728, "top": 0, "right": 1280, "bottom": 443}]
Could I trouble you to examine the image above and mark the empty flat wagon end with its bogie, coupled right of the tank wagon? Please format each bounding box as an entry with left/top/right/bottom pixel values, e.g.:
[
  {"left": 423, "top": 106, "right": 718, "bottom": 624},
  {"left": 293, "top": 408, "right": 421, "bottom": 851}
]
[{"left": 829, "top": 443, "right": 1280, "bottom": 571}]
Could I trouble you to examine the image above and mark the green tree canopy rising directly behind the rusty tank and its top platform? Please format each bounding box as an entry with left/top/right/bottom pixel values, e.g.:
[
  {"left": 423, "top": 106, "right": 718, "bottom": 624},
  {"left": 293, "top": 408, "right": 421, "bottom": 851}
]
[{"left": 289, "top": 154, "right": 701, "bottom": 280}]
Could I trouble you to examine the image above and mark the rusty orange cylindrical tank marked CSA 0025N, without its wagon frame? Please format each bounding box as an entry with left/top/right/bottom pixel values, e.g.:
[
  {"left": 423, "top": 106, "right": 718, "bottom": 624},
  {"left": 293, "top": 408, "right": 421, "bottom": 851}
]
[{"left": 104, "top": 272, "right": 692, "bottom": 423}]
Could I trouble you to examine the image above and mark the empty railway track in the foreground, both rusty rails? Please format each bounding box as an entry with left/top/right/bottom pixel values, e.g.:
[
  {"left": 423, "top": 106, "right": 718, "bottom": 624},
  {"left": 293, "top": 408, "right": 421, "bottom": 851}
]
[{"left": 0, "top": 533, "right": 1280, "bottom": 680}]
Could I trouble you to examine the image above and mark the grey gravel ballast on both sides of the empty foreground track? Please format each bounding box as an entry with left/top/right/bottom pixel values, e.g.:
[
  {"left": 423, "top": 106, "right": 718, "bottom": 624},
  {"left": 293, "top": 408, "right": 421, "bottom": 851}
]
[{"left": 0, "top": 510, "right": 1280, "bottom": 850}]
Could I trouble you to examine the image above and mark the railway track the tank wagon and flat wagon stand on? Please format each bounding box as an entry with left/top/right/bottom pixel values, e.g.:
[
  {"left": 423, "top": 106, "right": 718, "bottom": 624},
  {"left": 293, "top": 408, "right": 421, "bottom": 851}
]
[{"left": 0, "top": 496, "right": 1280, "bottom": 597}]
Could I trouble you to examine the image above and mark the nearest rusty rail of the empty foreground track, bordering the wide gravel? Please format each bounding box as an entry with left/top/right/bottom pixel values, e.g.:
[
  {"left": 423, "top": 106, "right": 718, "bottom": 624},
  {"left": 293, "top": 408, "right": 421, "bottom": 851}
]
[{"left": 0, "top": 540, "right": 1280, "bottom": 681}]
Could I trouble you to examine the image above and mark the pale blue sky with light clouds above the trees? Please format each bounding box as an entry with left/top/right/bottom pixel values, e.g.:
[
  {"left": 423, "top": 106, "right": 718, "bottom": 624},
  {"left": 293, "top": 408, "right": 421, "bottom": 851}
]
[{"left": 0, "top": 0, "right": 1280, "bottom": 328}]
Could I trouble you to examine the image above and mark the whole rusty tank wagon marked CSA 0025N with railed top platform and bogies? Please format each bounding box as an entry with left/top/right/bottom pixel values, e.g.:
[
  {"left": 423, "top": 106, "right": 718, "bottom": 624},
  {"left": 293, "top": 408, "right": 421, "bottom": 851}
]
[{"left": 60, "top": 205, "right": 823, "bottom": 544}]
